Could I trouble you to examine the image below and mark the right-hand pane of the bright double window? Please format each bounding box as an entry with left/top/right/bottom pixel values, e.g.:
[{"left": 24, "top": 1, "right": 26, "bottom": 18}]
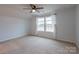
[{"left": 46, "top": 15, "right": 56, "bottom": 32}]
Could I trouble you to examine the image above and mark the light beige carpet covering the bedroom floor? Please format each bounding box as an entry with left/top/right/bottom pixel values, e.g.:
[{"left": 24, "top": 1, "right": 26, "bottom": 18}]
[{"left": 0, "top": 36, "right": 77, "bottom": 54}]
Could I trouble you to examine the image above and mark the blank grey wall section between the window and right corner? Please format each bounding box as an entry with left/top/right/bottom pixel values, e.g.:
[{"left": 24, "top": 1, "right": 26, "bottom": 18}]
[{"left": 56, "top": 7, "right": 76, "bottom": 42}]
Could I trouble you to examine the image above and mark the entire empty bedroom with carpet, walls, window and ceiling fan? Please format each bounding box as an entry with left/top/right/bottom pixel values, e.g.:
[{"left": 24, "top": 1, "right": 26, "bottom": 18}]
[{"left": 0, "top": 4, "right": 79, "bottom": 54}]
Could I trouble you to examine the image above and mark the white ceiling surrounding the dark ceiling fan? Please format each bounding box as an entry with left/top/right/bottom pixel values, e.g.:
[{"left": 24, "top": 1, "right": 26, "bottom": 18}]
[{"left": 0, "top": 4, "right": 74, "bottom": 18}]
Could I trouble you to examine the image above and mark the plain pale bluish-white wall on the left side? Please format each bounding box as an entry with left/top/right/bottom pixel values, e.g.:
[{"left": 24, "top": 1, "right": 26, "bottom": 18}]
[{"left": 0, "top": 16, "right": 29, "bottom": 42}]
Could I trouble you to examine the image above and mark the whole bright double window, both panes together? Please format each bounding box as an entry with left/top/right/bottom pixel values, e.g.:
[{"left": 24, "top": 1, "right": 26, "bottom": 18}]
[{"left": 37, "top": 15, "right": 56, "bottom": 32}]
